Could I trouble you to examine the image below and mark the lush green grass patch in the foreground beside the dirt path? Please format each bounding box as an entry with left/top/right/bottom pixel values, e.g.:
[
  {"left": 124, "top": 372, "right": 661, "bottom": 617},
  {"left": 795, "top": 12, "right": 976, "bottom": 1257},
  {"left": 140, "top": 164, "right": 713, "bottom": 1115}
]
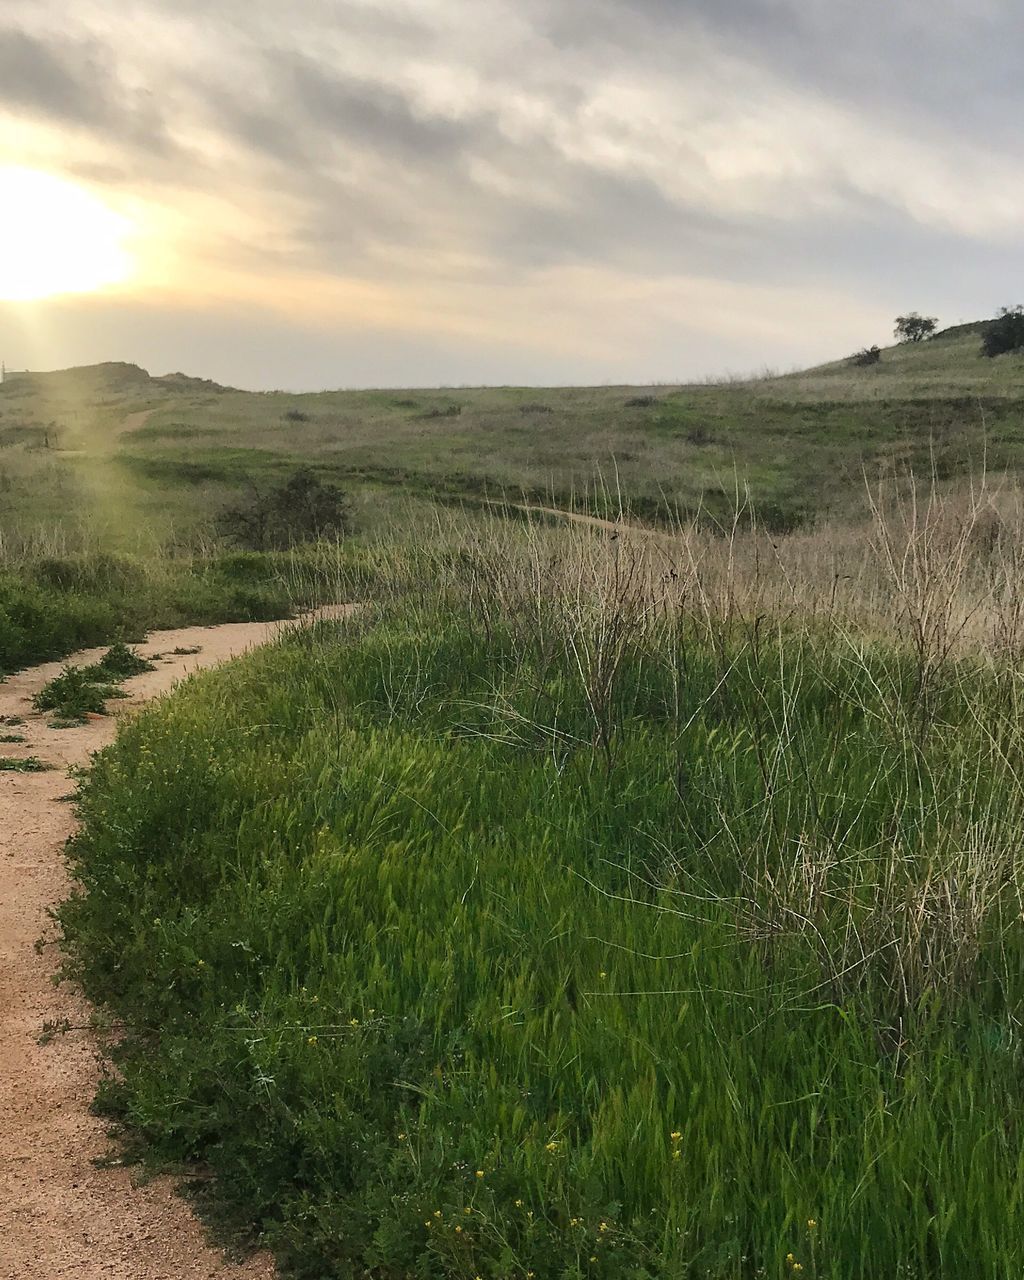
[{"left": 61, "top": 599, "right": 1024, "bottom": 1280}]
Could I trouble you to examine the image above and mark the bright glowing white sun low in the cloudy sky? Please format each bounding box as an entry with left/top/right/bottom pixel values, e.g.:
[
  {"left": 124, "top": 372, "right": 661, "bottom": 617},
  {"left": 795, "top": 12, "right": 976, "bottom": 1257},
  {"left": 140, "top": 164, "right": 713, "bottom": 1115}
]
[{"left": 0, "top": 166, "right": 132, "bottom": 302}]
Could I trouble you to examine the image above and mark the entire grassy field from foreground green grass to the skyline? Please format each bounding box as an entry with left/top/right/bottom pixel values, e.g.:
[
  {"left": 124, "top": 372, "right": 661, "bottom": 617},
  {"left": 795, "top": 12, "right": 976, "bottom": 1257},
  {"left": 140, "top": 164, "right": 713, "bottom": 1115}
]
[{"left": 10, "top": 333, "right": 1024, "bottom": 1280}]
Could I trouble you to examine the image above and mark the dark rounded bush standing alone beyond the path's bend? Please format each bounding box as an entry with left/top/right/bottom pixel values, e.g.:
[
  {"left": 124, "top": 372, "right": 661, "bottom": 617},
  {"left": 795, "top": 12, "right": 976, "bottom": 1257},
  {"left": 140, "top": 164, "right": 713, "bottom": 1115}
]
[{"left": 218, "top": 467, "right": 349, "bottom": 552}]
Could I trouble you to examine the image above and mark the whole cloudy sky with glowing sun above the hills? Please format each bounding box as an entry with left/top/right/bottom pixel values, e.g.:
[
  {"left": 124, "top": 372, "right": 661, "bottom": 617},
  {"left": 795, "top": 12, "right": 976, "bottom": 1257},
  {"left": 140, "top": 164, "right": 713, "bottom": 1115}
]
[{"left": 0, "top": 0, "right": 1024, "bottom": 389}]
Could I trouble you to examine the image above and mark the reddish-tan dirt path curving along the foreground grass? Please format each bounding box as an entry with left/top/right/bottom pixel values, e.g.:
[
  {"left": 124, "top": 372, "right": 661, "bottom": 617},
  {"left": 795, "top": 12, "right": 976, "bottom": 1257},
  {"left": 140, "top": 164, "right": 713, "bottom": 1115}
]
[{"left": 0, "top": 608, "right": 343, "bottom": 1280}]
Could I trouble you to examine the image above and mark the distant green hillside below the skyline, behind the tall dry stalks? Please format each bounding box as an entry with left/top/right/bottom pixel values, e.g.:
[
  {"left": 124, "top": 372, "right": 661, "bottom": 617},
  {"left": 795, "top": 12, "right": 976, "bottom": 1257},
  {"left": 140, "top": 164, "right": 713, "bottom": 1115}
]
[{"left": 0, "top": 328, "right": 1024, "bottom": 545}]
